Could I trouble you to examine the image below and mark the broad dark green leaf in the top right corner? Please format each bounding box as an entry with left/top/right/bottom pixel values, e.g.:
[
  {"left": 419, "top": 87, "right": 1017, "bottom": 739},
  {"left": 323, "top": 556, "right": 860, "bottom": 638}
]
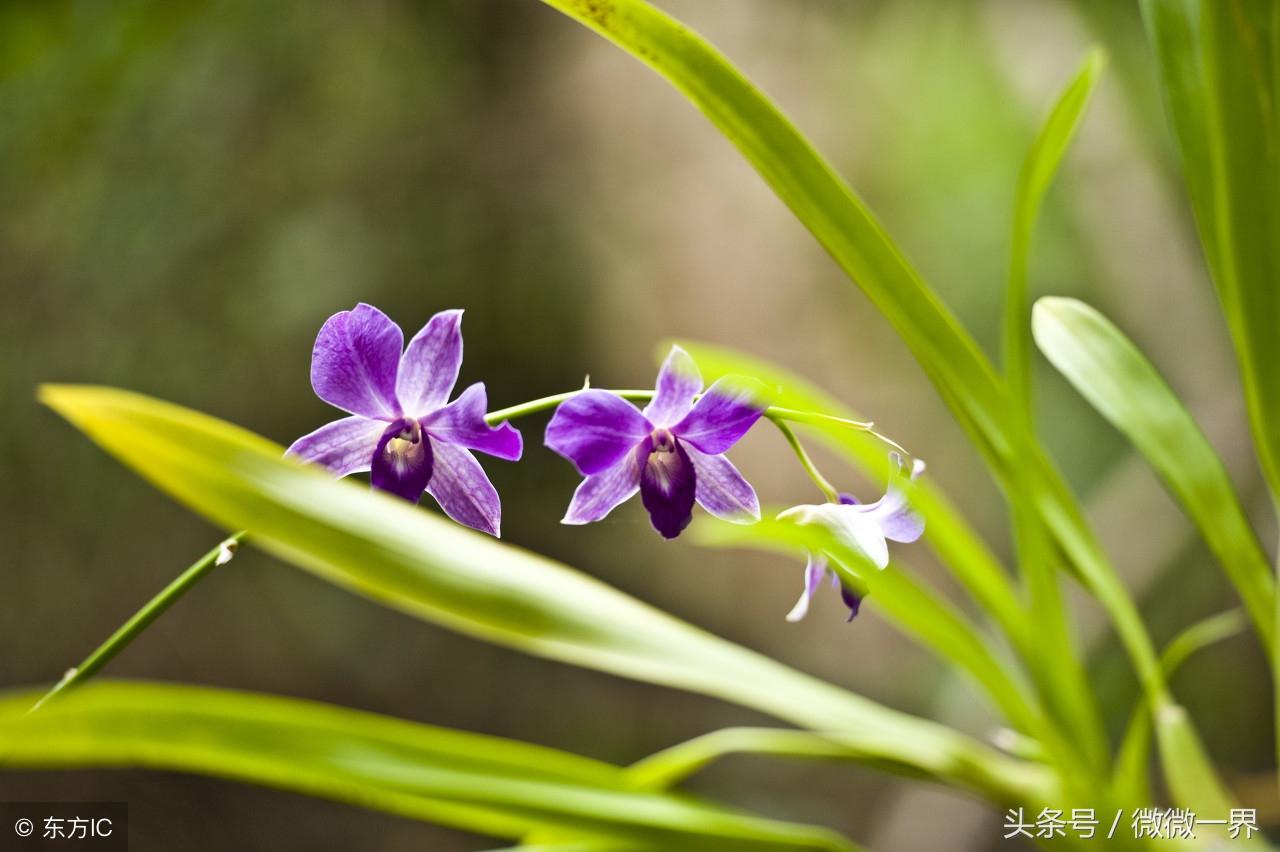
[{"left": 1144, "top": 0, "right": 1280, "bottom": 500}]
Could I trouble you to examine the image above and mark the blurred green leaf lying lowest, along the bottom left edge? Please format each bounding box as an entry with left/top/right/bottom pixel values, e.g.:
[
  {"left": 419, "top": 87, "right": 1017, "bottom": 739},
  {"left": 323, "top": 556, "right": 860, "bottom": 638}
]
[{"left": 0, "top": 682, "right": 852, "bottom": 849}]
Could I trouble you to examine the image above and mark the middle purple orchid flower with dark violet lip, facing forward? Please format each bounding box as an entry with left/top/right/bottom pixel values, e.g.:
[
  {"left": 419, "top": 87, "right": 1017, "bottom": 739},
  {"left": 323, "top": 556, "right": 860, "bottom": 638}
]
[{"left": 547, "top": 347, "right": 764, "bottom": 539}]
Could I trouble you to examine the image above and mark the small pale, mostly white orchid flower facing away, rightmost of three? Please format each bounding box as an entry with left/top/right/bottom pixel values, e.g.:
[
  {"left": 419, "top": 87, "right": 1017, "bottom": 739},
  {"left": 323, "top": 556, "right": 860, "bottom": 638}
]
[{"left": 778, "top": 453, "right": 924, "bottom": 622}]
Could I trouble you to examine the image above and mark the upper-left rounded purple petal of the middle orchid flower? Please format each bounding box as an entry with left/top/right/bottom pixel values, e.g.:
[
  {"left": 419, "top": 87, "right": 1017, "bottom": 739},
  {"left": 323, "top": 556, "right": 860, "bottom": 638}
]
[{"left": 545, "top": 390, "right": 652, "bottom": 476}]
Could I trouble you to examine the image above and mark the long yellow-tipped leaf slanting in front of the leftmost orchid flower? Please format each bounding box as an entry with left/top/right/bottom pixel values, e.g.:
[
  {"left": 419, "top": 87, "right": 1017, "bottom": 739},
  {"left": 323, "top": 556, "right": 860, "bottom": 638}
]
[{"left": 41, "top": 385, "right": 1039, "bottom": 801}]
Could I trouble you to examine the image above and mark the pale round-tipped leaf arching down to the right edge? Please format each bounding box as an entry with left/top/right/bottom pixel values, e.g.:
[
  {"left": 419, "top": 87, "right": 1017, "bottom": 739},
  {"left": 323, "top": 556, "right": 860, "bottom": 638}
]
[{"left": 1034, "top": 298, "right": 1275, "bottom": 652}]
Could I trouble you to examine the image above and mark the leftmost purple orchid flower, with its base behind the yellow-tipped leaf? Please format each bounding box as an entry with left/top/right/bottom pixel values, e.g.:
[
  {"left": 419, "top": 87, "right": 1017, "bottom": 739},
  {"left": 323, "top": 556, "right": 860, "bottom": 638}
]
[{"left": 285, "top": 303, "right": 522, "bottom": 536}]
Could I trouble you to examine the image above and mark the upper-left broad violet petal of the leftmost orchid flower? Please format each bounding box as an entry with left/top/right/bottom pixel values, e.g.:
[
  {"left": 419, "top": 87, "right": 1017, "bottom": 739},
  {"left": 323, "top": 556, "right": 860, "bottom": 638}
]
[{"left": 311, "top": 302, "right": 404, "bottom": 420}]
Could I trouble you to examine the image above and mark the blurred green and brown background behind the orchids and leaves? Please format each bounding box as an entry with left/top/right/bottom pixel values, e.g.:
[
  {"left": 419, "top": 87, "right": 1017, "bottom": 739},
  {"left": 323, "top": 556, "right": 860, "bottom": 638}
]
[{"left": 0, "top": 0, "right": 1280, "bottom": 851}]
